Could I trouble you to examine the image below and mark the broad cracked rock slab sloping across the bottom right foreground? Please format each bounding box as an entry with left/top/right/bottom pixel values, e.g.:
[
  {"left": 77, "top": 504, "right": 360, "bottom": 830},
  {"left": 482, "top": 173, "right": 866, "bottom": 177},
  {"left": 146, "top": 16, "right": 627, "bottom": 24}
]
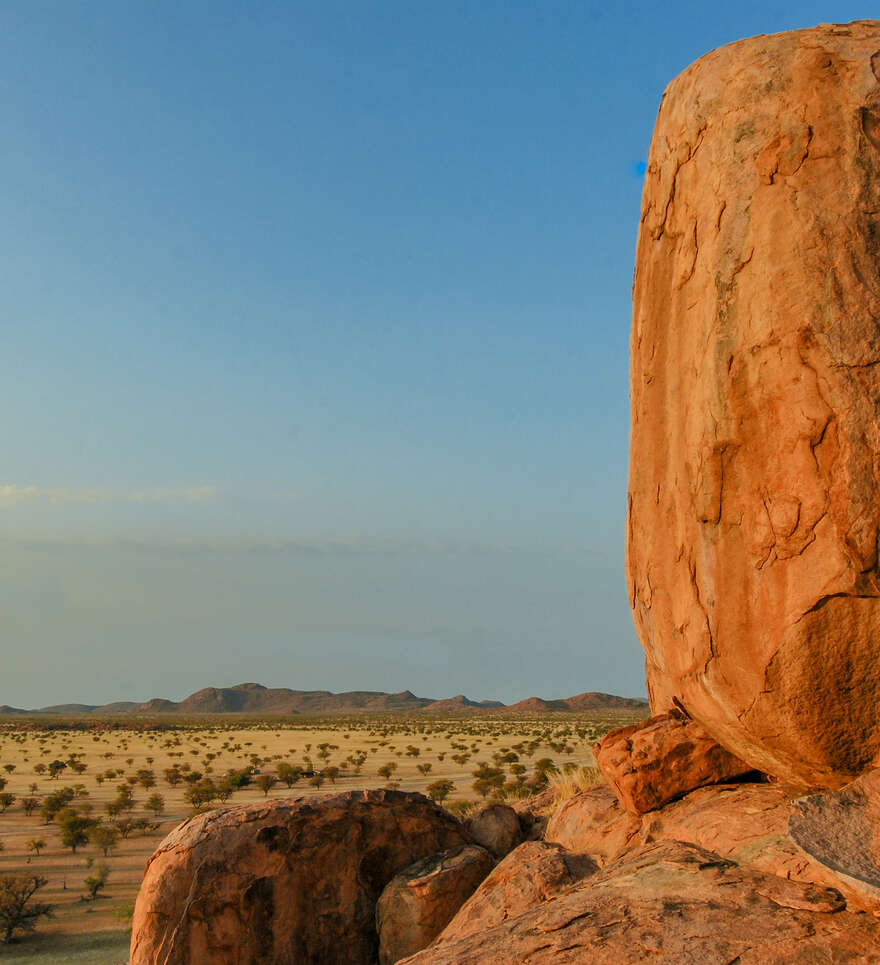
[{"left": 401, "top": 841, "right": 880, "bottom": 965}]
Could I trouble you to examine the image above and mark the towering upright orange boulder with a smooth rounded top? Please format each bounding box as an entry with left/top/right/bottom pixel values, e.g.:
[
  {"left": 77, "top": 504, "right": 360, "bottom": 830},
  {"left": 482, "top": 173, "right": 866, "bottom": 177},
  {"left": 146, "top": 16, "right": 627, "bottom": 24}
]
[{"left": 627, "top": 21, "right": 880, "bottom": 787}]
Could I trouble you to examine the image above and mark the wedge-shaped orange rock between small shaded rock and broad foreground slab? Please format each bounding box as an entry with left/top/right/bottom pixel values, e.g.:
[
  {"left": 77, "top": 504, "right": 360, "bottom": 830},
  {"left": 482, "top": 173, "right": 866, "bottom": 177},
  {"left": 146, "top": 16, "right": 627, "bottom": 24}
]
[{"left": 437, "top": 841, "right": 597, "bottom": 944}]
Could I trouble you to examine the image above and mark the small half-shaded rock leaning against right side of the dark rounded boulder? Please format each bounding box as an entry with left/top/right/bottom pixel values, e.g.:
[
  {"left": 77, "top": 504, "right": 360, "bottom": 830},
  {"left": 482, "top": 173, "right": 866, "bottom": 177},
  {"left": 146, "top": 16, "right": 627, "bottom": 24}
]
[{"left": 376, "top": 845, "right": 495, "bottom": 965}]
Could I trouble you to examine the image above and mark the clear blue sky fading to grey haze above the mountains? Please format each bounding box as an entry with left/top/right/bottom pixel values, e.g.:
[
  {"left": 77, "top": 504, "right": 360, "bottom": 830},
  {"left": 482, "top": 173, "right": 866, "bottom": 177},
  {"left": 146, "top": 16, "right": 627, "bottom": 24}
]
[{"left": 0, "top": 0, "right": 870, "bottom": 707}]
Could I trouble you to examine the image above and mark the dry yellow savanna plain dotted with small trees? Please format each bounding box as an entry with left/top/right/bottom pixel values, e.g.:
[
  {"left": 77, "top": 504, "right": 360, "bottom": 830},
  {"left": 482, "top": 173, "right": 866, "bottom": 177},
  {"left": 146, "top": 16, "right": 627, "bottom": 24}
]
[{"left": 0, "top": 714, "right": 635, "bottom": 965}]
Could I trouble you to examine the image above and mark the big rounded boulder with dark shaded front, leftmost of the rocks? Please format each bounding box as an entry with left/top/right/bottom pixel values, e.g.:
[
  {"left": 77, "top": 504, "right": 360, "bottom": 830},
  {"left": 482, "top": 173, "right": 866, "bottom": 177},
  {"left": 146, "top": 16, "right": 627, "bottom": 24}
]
[{"left": 131, "top": 790, "right": 468, "bottom": 965}]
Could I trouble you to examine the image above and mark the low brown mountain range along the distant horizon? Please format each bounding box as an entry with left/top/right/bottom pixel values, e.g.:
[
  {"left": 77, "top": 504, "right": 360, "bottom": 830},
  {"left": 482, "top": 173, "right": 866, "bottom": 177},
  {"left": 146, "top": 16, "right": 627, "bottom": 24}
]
[{"left": 0, "top": 684, "right": 648, "bottom": 716}]
